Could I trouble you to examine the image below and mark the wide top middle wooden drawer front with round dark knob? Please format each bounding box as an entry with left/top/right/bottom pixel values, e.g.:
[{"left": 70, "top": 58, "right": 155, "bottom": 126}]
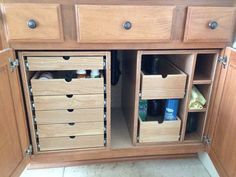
[{"left": 76, "top": 5, "right": 175, "bottom": 43}]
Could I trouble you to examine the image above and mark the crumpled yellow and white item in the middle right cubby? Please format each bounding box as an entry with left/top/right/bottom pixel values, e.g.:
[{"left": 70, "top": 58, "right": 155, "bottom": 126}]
[{"left": 189, "top": 86, "right": 206, "bottom": 109}]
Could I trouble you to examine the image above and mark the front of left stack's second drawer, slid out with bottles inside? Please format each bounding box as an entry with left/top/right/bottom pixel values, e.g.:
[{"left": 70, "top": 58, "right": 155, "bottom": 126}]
[{"left": 31, "top": 78, "right": 104, "bottom": 96}]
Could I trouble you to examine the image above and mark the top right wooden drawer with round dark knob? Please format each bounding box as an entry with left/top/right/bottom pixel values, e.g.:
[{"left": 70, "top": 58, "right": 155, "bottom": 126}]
[{"left": 184, "top": 7, "right": 235, "bottom": 42}]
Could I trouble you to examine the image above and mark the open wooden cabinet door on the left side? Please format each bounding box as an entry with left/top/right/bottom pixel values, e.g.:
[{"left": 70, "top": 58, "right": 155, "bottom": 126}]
[{"left": 0, "top": 49, "right": 30, "bottom": 177}]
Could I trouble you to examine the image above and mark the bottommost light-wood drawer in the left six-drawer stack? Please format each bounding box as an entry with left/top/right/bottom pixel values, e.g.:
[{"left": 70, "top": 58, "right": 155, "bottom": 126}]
[{"left": 39, "top": 135, "right": 104, "bottom": 151}]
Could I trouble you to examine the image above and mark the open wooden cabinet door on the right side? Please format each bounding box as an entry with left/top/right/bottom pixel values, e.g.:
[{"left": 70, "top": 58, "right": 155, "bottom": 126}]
[{"left": 209, "top": 48, "right": 236, "bottom": 177}]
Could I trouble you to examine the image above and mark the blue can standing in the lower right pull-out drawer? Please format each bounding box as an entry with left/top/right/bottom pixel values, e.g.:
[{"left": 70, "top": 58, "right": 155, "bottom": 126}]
[{"left": 164, "top": 99, "right": 179, "bottom": 120}]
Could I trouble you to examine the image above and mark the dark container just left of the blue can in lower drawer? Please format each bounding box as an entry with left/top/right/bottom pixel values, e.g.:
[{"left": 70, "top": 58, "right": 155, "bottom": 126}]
[{"left": 148, "top": 100, "right": 162, "bottom": 116}]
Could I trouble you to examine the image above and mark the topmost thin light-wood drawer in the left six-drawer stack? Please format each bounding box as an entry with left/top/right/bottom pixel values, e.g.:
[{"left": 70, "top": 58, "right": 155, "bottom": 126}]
[{"left": 27, "top": 54, "right": 103, "bottom": 71}]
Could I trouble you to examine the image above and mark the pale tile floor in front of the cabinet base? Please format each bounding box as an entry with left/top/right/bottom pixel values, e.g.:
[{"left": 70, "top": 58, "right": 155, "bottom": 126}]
[{"left": 21, "top": 158, "right": 210, "bottom": 177}]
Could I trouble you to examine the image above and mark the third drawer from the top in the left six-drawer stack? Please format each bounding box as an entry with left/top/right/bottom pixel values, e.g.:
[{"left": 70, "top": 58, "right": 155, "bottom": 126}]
[{"left": 34, "top": 94, "right": 104, "bottom": 110}]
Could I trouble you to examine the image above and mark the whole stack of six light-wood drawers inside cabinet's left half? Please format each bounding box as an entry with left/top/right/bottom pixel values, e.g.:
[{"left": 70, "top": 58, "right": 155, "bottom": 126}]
[{"left": 22, "top": 52, "right": 110, "bottom": 151}]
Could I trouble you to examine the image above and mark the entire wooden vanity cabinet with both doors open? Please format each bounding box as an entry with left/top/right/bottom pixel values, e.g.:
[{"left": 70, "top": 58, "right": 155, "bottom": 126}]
[{"left": 0, "top": 0, "right": 236, "bottom": 177}]
